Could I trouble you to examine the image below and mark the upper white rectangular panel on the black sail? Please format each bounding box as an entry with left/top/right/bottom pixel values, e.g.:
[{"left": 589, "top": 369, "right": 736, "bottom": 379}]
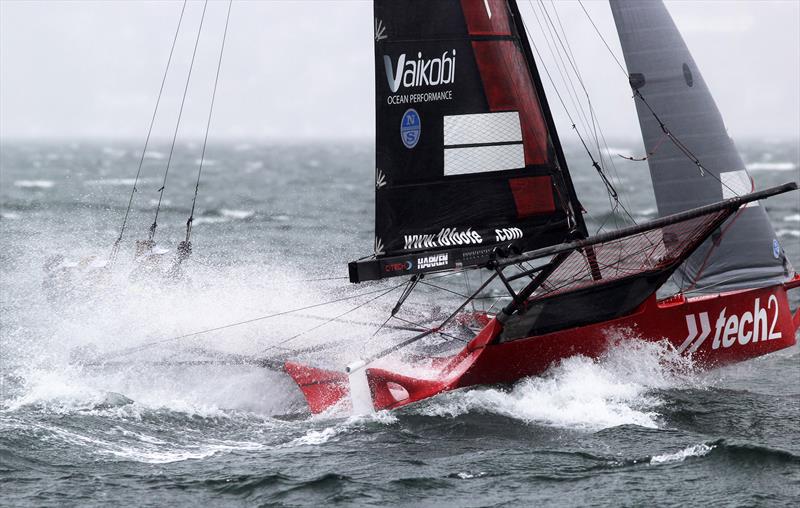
[{"left": 444, "top": 111, "right": 522, "bottom": 146}]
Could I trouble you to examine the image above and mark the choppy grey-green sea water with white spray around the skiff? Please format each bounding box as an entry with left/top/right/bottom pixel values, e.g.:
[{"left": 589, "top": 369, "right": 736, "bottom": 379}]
[{"left": 0, "top": 141, "right": 800, "bottom": 506}]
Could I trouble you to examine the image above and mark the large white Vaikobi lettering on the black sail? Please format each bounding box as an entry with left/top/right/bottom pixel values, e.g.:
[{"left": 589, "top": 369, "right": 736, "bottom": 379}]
[{"left": 383, "top": 49, "right": 456, "bottom": 93}]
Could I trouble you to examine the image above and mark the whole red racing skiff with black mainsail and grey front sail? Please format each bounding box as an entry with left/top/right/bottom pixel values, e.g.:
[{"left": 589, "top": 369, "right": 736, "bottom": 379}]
[{"left": 275, "top": 0, "right": 800, "bottom": 413}]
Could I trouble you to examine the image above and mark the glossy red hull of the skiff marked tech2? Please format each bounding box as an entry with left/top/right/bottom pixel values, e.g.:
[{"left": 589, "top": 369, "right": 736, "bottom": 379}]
[{"left": 284, "top": 276, "right": 800, "bottom": 413}]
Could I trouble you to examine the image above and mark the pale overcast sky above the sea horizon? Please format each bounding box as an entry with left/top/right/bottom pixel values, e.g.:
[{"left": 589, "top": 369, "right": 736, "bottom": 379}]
[{"left": 0, "top": 0, "right": 800, "bottom": 140}]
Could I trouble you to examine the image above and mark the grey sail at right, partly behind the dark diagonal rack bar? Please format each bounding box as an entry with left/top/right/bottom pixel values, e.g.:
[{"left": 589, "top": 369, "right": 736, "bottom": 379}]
[{"left": 610, "top": 0, "right": 793, "bottom": 292}]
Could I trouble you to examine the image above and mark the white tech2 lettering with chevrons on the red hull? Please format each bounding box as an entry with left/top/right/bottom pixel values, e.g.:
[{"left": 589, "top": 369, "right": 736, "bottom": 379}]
[{"left": 678, "top": 295, "right": 783, "bottom": 353}]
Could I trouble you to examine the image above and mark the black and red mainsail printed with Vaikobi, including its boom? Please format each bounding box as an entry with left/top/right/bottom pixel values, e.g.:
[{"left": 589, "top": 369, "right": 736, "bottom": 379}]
[{"left": 350, "top": 0, "right": 586, "bottom": 282}]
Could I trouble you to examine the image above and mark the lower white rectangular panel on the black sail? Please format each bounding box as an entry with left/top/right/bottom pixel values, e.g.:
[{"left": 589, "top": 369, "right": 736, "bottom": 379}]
[{"left": 444, "top": 143, "right": 525, "bottom": 176}]
